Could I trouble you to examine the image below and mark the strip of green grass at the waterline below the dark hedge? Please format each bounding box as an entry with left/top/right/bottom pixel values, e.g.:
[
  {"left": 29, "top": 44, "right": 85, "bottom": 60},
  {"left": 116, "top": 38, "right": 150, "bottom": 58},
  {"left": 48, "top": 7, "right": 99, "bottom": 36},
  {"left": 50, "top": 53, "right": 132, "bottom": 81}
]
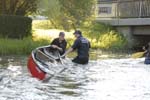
[{"left": 0, "top": 37, "right": 48, "bottom": 55}]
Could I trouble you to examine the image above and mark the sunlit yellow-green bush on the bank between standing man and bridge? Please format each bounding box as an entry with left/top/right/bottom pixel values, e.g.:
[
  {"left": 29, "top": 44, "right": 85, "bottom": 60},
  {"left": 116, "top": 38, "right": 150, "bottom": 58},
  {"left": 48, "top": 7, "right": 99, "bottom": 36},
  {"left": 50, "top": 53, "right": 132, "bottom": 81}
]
[{"left": 91, "top": 31, "right": 126, "bottom": 50}]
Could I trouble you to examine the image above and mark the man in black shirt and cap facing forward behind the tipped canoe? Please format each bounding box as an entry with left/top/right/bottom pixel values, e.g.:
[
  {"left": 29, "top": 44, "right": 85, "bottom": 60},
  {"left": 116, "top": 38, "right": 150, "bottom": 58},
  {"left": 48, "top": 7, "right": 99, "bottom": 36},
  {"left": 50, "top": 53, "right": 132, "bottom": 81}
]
[{"left": 51, "top": 32, "right": 67, "bottom": 55}]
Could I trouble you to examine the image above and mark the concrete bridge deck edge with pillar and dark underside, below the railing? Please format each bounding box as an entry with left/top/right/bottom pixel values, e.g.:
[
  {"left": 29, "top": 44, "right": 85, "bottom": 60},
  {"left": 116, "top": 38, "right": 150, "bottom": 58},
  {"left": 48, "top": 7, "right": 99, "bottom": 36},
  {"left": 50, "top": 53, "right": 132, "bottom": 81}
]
[{"left": 97, "top": 18, "right": 150, "bottom": 48}]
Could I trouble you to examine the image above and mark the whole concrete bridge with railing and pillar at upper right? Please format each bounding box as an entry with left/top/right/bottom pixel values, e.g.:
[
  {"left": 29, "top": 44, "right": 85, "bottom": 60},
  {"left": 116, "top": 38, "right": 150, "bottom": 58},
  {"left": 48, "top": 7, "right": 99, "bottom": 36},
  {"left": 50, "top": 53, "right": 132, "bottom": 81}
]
[{"left": 96, "top": 0, "right": 150, "bottom": 47}]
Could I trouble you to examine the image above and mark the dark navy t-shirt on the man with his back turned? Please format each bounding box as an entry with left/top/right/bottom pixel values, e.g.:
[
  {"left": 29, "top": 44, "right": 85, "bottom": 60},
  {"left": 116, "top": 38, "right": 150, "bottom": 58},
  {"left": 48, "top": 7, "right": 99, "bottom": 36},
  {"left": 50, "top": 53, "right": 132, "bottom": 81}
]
[{"left": 72, "top": 36, "right": 90, "bottom": 58}]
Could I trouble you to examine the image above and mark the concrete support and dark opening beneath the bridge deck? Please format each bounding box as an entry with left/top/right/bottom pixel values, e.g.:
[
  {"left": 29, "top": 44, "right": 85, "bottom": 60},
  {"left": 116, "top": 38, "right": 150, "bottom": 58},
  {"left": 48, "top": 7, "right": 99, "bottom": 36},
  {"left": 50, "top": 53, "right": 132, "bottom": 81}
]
[{"left": 115, "top": 26, "right": 150, "bottom": 49}]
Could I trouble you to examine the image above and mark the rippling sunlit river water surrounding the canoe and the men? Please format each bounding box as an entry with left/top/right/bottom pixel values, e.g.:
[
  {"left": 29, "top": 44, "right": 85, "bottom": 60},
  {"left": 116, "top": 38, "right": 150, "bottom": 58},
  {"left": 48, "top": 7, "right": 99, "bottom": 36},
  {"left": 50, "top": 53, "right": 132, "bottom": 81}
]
[{"left": 0, "top": 55, "right": 150, "bottom": 100}]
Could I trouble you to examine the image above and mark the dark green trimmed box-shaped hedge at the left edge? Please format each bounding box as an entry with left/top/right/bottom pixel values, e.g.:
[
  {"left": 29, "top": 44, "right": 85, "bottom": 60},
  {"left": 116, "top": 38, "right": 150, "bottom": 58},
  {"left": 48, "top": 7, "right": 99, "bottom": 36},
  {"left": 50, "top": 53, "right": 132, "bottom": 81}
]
[{"left": 0, "top": 15, "right": 32, "bottom": 38}]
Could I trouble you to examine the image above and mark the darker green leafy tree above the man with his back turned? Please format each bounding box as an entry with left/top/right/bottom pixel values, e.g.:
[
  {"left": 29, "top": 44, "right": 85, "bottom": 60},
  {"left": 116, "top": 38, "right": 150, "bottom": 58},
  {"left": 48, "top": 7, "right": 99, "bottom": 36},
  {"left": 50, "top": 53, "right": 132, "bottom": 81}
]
[{"left": 59, "top": 0, "right": 96, "bottom": 28}]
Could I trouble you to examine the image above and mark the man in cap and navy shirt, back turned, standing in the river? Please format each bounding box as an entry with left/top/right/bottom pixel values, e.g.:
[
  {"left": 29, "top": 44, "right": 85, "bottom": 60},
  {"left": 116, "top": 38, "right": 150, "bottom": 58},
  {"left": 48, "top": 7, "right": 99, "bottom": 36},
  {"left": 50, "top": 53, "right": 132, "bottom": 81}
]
[{"left": 63, "top": 30, "right": 90, "bottom": 64}]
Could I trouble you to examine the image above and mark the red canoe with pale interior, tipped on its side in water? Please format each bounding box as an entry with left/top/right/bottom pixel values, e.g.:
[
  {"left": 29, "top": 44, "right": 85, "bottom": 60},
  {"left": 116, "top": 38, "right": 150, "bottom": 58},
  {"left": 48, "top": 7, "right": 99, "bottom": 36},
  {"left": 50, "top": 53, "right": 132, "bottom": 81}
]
[{"left": 27, "top": 46, "right": 60, "bottom": 80}]
